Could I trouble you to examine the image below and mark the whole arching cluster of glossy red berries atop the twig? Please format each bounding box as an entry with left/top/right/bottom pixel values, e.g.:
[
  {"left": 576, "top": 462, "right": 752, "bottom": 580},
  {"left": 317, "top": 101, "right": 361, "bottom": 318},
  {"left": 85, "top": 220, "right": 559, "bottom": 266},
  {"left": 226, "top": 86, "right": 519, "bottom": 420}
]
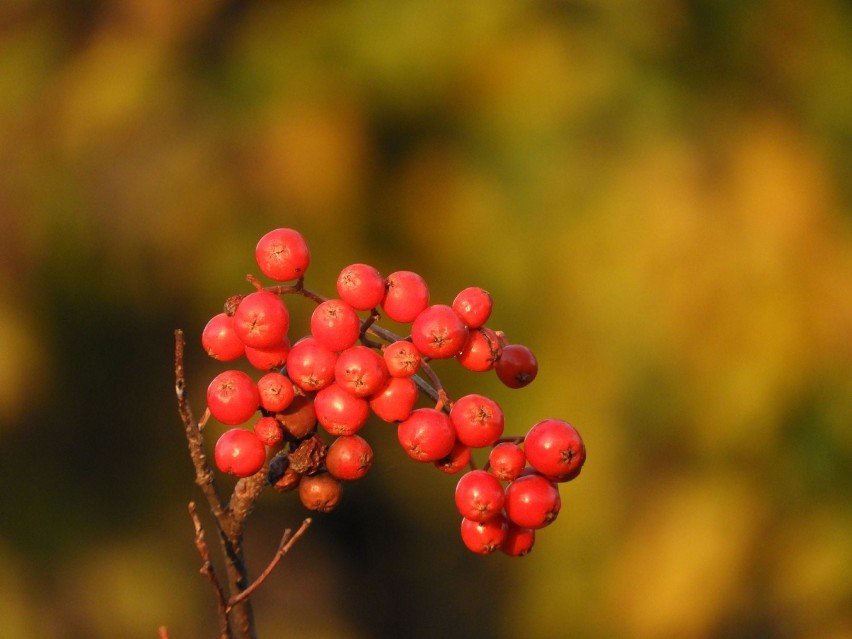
[{"left": 201, "top": 228, "right": 586, "bottom": 556}]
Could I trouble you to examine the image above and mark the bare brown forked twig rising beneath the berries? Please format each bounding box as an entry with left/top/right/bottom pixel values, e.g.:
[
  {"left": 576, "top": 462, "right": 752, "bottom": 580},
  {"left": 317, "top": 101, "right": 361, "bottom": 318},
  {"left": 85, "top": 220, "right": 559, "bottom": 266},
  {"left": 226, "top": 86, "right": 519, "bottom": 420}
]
[{"left": 171, "top": 330, "right": 311, "bottom": 639}]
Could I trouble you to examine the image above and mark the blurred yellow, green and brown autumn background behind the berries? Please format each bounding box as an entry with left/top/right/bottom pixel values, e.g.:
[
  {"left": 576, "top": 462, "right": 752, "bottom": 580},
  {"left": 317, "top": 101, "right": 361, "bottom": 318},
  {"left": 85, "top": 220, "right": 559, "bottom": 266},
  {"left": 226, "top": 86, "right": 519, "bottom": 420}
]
[{"left": 0, "top": 0, "right": 852, "bottom": 639}]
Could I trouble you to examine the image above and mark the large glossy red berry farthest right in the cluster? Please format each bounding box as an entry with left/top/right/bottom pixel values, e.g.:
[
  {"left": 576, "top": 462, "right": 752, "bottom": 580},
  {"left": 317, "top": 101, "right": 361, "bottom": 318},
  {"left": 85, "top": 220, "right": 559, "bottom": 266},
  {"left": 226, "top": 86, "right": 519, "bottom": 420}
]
[{"left": 524, "top": 419, "right": 586, "bottom": 481}]
